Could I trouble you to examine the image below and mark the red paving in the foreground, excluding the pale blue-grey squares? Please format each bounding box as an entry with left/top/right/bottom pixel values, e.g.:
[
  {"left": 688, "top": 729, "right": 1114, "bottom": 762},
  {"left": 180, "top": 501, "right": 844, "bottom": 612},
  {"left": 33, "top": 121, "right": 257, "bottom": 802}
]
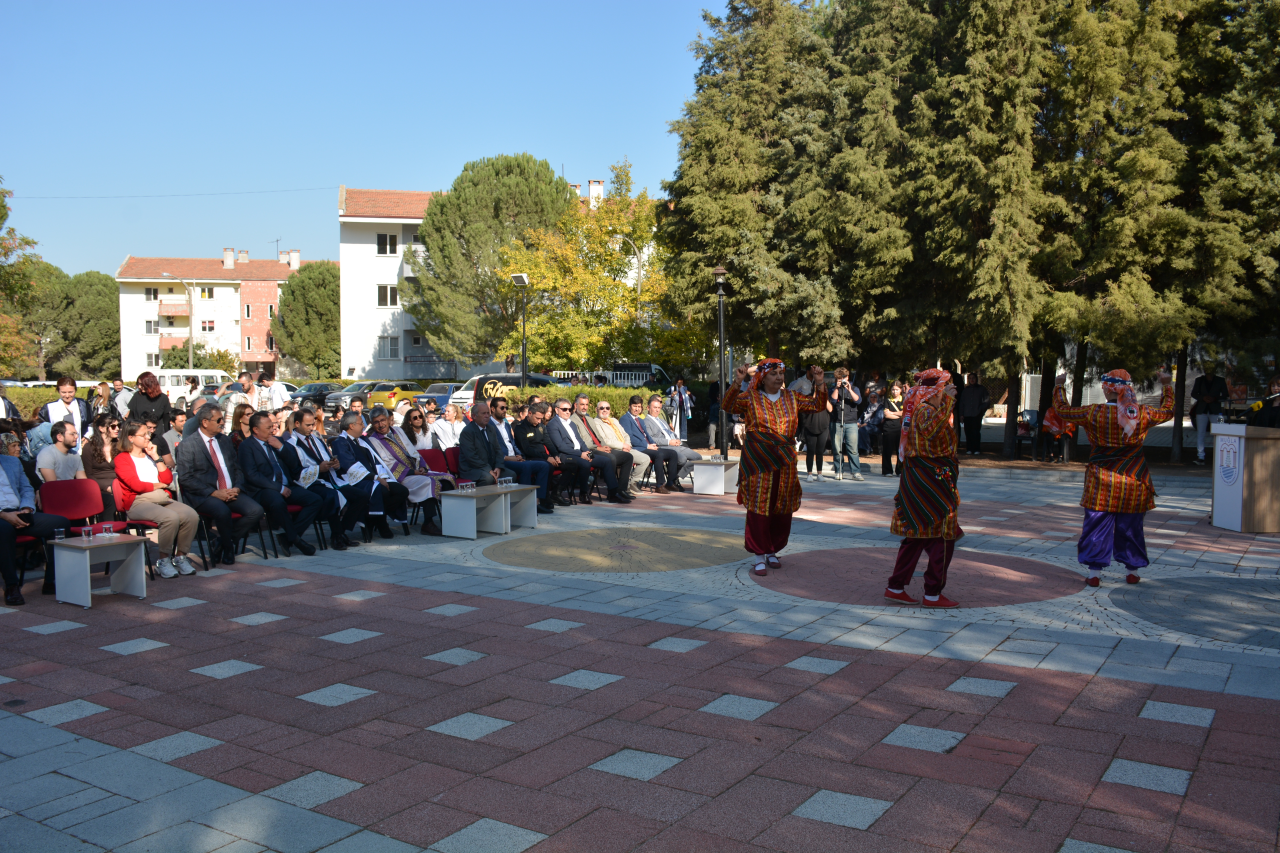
[{"left": 0, "top": 555, "right": 1280, "bottom": 853}]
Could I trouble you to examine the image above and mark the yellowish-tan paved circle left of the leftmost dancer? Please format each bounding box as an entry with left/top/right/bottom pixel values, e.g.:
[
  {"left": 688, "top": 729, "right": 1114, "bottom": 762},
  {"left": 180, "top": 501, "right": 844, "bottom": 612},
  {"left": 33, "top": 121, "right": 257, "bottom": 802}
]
[{"left": 483, "top": 528, "right": 748, "bottom": 573}]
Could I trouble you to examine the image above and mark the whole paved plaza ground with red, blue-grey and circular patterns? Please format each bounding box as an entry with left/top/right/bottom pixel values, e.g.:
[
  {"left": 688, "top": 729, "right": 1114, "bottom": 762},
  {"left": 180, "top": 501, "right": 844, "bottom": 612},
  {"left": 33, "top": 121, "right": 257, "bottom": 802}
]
[{"left": 0, "top": 470, "right": 1280, "bottom": 853}]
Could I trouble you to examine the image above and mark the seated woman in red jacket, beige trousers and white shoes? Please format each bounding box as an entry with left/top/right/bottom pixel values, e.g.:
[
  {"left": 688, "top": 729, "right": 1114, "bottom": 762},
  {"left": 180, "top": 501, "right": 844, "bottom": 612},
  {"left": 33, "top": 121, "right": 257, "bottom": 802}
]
[{"left": 111, "top": 421, "right": 200, "bottom": 578}]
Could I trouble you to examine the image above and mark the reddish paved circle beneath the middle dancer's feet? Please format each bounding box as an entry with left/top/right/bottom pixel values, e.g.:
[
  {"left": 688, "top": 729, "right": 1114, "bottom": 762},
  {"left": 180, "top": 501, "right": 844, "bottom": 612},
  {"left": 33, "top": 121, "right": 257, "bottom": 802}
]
[{"left": 751, "top": 548, "right": 1084, "bottom": 607}]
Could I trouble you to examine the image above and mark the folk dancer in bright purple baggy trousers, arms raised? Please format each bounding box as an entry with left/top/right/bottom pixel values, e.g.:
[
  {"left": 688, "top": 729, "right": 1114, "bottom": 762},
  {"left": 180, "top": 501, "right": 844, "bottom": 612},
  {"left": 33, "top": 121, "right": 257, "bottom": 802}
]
[{"left": 1053, "top": 370, "right": 1174, "bottom": 587}]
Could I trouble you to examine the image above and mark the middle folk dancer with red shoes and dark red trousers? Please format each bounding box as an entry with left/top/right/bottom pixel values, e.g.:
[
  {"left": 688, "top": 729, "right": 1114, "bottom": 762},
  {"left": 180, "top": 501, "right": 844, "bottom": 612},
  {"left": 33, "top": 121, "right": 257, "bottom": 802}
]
[{"left": 884, "top": 369, "right": 964, "bottom": 607}]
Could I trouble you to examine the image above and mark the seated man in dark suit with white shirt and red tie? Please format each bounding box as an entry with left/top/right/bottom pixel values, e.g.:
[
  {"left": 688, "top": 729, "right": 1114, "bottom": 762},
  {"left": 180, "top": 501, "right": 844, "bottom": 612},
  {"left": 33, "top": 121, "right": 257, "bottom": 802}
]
[{"left": 178, "top": 406, "right": 262, "bottom": 565}]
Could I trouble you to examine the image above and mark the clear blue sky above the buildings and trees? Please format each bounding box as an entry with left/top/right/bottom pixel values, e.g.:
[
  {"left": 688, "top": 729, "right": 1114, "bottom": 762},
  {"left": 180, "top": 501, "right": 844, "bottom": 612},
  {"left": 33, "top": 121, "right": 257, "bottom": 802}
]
[{"left": 0, "top": 0, "right": 722, "bottom": 274}]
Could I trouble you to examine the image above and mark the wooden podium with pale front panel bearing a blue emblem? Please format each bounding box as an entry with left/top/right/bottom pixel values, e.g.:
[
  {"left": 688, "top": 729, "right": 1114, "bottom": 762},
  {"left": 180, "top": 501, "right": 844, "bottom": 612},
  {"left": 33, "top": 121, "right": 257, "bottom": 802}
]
[{"left": 1210, "top": 424, "right": 1280, "bottom": 533}]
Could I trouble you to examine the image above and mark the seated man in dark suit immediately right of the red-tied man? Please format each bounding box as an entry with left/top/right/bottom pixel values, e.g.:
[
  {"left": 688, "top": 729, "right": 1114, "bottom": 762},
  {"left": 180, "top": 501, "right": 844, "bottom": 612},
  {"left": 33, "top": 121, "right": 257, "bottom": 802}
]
[{"left": 239, "top": 411, "right": 322, "bottom": 557}]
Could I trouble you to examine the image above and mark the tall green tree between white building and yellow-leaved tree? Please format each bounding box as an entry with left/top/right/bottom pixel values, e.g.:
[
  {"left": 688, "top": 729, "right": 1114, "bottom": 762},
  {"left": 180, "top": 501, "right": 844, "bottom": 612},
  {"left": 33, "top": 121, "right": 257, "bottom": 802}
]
[{"left": 401, "top": 154, "right": 579, "bottom": 361}]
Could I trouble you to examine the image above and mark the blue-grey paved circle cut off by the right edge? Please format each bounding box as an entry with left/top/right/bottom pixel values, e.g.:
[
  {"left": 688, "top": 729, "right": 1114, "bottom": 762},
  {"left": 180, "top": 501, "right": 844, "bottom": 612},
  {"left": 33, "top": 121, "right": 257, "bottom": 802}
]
[{"left": 1111, "top": 578, "right": 1280, "bottom": 648}]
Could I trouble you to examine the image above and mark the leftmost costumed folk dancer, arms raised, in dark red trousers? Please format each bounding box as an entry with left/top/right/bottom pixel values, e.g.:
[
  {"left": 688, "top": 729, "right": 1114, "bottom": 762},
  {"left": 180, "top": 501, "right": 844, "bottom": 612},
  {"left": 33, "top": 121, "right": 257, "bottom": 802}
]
[{"left": 722, "top": 359, "right": 827, "bottom": 576}]
